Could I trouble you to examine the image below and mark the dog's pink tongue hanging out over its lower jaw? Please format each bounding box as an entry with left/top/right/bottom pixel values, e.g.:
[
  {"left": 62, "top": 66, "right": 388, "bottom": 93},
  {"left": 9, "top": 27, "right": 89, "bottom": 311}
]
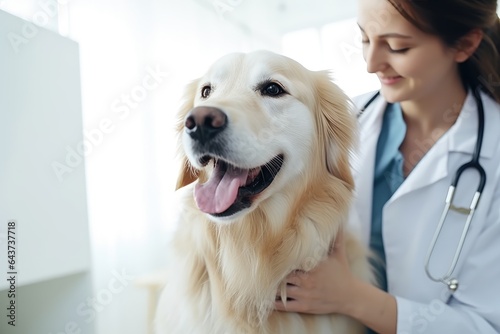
[{"left": 194, "top": 166, "right": 248, "bottom": 214}]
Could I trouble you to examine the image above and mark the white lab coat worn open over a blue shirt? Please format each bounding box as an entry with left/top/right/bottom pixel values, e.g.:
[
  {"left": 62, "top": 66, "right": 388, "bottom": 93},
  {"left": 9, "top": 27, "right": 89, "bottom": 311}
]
[{"left": 351, "top": 93, "right": 500, "bottom": 334}]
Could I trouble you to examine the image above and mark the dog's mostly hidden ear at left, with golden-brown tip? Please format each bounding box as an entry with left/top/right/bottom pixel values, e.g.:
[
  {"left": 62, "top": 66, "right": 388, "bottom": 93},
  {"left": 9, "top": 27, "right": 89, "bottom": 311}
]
[{"left": 175, "top": 80, "right": 198, "bottom": 190}]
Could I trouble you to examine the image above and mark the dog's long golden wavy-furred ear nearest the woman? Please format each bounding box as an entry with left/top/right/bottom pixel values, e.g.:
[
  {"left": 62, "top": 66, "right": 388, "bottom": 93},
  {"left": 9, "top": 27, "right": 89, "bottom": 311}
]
[{"left": 315, "top": 71, "right": 357, "bottom": 187}]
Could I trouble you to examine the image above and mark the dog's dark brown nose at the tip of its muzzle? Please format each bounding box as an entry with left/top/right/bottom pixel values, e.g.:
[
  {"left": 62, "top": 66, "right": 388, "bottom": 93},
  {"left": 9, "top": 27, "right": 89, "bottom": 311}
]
[{"left": 184, "top": 107, "right": 227, "bottom": 142}]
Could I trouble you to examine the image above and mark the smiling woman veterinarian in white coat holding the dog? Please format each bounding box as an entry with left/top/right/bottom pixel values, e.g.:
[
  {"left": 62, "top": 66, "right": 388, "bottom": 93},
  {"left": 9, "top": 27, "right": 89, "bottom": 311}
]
[{"left": 276, "top": 0, "right": 500, "bottom": 334}]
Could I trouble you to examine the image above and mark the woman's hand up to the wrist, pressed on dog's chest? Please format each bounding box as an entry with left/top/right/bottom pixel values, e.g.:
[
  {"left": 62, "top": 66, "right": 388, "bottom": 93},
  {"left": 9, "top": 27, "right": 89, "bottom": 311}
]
[{"left": 275, "top": 231, "right": 358, "bottom": 314}]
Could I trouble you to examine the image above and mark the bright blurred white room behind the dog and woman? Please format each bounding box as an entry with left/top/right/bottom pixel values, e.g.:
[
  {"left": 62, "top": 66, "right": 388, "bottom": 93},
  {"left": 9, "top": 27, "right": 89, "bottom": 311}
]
[{"left": 0, "top": 0, "right": 440, "bottom": 334}]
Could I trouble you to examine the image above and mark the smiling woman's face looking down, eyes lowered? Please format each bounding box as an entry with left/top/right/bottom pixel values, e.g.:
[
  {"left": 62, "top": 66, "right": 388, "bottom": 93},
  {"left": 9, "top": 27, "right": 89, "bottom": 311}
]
[{"left": 358, "top": 0, "right": 460, "bottom": 102}]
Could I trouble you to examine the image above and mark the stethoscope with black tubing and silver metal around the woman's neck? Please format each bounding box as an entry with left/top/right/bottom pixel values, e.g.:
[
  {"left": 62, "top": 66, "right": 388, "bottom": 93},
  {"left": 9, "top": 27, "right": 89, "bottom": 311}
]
[{"left": 357, "top": 90, "right": 486, "bottom": 293}]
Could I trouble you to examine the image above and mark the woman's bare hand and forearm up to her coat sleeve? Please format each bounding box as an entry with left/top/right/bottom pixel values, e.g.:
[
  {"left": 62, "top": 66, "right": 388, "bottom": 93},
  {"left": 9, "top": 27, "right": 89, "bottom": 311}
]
[{"left": 275, "top": 232, "right": 397, "bottom": 334}]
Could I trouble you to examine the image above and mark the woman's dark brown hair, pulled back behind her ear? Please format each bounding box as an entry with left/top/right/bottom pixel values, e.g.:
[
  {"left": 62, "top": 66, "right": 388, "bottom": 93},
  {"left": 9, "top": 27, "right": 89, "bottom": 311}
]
[{"left": 388, "top": 0, "right": 500, "bottom": 103}]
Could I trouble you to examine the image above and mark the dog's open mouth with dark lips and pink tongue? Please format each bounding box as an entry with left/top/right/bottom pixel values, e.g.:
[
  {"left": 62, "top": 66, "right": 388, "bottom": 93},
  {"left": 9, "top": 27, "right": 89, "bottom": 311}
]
[{"left": 194, "top": 154, "right": 283, "bottom": 217}]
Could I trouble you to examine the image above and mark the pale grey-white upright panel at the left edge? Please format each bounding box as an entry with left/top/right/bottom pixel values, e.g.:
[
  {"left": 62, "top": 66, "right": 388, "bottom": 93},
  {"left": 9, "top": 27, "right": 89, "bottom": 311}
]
[{"left": 0, "top": 11, "right": 90, "bottom": 289}]
